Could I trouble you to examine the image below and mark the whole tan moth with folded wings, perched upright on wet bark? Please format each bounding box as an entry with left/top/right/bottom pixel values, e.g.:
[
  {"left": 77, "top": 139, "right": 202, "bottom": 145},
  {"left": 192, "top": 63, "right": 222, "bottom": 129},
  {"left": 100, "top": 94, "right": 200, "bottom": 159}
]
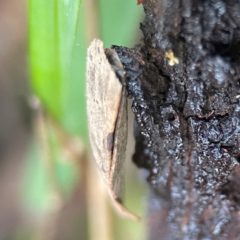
[{"left": 86, "top": 39, "right": 139, "bottom": 220}]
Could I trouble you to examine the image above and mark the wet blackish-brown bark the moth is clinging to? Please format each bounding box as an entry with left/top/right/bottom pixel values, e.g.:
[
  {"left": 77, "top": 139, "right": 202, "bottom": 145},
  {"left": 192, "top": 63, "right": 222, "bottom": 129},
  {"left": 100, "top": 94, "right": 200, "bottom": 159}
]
[{"left": 113, "top": 0, "right": 240, "bottom": 240}]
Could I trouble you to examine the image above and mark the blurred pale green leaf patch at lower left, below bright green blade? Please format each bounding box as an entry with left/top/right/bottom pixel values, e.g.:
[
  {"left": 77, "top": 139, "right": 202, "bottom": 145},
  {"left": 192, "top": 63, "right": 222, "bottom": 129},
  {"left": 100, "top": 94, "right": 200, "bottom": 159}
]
[{"left": 23, "top": 131, "right": 80, "bottom": 213}]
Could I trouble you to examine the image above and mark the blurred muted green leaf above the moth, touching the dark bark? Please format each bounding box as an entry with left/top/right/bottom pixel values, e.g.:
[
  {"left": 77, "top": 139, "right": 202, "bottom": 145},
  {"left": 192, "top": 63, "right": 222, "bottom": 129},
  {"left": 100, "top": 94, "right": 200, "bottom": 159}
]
[{"left": 99, "top": 0, "right": 143, "bottom": 47}]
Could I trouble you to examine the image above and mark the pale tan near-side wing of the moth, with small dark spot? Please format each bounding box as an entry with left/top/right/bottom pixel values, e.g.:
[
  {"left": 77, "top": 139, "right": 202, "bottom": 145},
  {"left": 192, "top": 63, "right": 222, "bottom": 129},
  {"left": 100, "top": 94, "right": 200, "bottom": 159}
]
[{"left": 86, "top": 39, "right": 122, "bottom": 186}]
